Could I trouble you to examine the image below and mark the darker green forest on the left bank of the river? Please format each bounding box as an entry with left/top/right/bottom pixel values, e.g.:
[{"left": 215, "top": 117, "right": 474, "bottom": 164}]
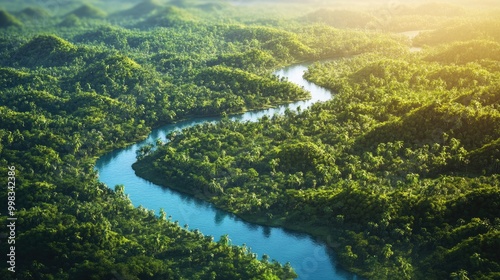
[{"left": 0, "top": 1, "right": 336, "bottom": 279}]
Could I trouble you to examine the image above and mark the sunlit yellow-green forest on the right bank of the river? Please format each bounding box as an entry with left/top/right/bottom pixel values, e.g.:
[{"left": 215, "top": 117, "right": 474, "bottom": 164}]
[{"left": 134, "top": 13, "right": 500, "bottom": 279}]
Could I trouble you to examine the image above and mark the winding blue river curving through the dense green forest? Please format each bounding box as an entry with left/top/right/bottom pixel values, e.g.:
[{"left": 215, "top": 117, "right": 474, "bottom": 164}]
[{"left": 96, "top": 63, "right": 356, "bottom": 280}]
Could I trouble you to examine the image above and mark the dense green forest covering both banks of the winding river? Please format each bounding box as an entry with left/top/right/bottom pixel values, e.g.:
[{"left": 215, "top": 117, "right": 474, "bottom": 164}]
[{"left": 0, "top": 0, "right": 500, "bottom": 279}]
